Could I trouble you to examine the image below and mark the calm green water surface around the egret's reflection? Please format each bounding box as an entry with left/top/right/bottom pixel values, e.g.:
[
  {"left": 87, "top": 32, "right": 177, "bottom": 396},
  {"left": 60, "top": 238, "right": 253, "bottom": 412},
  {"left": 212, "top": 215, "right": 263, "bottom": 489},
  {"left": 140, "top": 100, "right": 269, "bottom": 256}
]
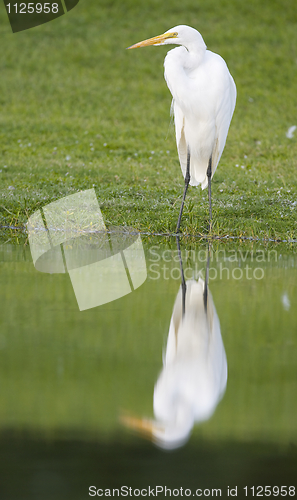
[{"left": 0, "top": 239, "right": 297, "bottom": 500}]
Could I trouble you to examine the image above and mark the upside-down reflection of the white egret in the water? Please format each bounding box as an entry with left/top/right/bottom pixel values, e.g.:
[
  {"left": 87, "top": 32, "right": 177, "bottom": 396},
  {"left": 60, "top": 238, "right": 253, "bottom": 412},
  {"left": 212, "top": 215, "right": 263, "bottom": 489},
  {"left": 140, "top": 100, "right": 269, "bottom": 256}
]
[{"left": 122, "top": 239, "right": 227, "bottom": 449}]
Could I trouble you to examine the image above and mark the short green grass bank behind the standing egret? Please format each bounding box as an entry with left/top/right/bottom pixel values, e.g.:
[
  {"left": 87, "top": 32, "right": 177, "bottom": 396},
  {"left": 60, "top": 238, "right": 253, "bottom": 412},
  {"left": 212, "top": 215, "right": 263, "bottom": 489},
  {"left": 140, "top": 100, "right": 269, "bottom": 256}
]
[{"left": 0, "top": 0, "right": 297, "bottom": 240}]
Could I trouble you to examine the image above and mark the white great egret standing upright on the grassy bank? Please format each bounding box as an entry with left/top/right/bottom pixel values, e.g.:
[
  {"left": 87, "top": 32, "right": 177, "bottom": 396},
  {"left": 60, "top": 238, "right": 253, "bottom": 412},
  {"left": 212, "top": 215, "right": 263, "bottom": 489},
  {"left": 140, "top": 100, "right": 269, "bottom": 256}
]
[{"left": 128, "top": 25, "right": 236, "bottom": 232}]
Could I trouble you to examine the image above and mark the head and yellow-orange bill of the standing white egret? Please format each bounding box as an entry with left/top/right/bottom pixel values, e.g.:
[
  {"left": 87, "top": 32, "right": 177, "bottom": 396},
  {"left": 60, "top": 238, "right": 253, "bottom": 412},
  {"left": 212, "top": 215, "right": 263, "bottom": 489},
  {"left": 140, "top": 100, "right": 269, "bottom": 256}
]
[{"left": 128, "top": 24, "right": 206, "bottom": 50}]
